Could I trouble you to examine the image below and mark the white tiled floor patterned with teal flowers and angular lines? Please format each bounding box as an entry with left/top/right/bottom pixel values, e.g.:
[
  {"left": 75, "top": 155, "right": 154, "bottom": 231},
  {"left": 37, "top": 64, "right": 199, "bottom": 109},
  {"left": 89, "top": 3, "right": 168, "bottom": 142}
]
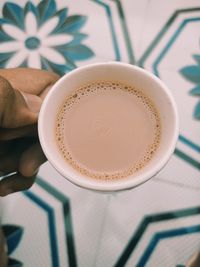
[{"left": 0, "top": 0, "right": 200, "bottom": 267}]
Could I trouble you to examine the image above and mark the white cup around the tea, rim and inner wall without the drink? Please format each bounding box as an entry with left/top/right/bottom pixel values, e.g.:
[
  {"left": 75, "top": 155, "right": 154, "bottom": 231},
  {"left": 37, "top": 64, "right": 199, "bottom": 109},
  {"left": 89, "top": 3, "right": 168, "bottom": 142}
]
[{"left": 38, "top": 62, "right": 179, "bottom": 192}]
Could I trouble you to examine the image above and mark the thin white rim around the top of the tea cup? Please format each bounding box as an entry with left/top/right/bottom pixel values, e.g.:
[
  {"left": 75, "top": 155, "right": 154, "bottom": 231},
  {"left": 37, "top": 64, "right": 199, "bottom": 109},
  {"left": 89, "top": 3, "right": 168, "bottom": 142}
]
[{"left": 38, "top": 61, "right": 179, "bottom": 192}]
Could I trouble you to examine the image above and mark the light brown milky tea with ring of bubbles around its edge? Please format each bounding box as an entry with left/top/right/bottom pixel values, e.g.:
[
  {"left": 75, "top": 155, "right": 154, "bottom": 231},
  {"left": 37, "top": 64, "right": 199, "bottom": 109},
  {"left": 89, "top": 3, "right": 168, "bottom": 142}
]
[{"left": 56, "top": 81, "right": 161, "bottom": 180}]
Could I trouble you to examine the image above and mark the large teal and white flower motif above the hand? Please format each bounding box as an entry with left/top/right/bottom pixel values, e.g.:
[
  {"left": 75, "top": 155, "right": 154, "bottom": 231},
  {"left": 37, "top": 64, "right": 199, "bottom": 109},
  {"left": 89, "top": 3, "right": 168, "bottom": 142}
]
[{"left": 0, "top": 0, "right": 94, "bottom": 75}]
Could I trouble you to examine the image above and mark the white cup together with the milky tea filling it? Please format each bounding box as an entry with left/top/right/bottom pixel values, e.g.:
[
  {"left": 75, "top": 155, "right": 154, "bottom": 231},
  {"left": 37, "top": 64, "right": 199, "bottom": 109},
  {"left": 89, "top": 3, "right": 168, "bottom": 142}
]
[{"left": 38, "top": 62, "right": 179, "bottom": 192}]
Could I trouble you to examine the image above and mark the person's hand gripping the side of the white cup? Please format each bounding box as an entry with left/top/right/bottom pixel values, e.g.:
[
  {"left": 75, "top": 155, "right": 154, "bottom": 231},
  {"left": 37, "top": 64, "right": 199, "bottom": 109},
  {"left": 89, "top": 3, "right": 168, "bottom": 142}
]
[{"left": 0, "top": 68, "right": 60, "bottom": 196}]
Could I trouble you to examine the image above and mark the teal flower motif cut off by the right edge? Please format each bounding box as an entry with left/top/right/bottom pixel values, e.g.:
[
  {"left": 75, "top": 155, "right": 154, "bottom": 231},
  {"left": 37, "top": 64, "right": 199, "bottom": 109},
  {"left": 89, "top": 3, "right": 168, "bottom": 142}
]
[{"left": 180, "top": 55, "right": 200, "bottom": 120}]
